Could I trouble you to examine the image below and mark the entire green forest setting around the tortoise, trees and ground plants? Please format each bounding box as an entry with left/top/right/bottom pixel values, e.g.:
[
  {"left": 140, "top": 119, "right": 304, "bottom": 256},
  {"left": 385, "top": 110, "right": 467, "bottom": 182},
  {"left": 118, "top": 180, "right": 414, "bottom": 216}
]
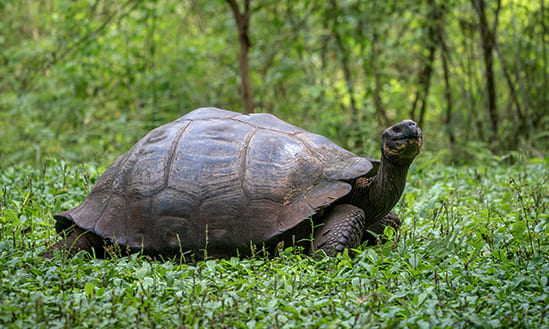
[{"left": 0, "top": 0, "right": 549, "bottom": 329}]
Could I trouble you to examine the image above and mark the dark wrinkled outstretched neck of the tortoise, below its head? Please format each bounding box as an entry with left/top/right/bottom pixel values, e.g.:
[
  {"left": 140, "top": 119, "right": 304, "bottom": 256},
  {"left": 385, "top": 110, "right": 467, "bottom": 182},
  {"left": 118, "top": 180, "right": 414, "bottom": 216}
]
[{"left": 348, "top": 157, "right": 412, "bottom": 225}]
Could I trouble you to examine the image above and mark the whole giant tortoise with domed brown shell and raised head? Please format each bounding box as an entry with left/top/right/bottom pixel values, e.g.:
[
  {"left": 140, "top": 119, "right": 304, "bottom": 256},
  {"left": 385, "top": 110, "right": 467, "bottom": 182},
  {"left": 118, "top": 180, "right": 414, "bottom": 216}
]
[{"left": 45, "top": 108, "right": 423, "bottom": 259}]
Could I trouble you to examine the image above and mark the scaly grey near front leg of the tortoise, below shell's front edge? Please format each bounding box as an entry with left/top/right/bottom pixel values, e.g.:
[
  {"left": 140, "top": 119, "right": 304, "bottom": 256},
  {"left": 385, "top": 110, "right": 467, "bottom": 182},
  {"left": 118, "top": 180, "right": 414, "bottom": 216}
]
[{"left": 311, "top": 204, "right": 366, "bottom": 256}]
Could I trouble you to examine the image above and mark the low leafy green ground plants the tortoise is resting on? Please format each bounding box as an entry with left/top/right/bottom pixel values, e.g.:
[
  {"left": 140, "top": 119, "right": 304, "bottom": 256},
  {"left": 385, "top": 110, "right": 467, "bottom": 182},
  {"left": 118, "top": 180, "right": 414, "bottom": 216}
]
[{"left": 0, "top": 155, "right": 549, "bottom": 328}]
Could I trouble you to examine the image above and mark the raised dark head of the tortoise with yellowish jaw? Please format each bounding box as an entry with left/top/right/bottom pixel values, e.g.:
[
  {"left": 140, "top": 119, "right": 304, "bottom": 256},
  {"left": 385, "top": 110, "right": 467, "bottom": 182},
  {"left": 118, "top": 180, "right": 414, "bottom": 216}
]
[{"left": 381, "top": 120, "right": 423, "bottom": 164}]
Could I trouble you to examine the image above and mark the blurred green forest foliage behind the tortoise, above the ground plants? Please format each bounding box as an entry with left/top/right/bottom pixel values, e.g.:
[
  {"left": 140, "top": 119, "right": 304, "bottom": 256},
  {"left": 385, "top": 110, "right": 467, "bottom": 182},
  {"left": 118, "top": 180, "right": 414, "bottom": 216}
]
[{"left": 0, "top": 0, "right": 549, "bottom": 166}]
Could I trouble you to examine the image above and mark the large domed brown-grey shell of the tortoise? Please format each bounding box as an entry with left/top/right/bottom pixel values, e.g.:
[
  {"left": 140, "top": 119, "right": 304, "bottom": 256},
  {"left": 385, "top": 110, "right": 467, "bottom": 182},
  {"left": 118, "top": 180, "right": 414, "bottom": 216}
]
[{"left": 55, "top": 108, "right": 372, "bottom": 251}]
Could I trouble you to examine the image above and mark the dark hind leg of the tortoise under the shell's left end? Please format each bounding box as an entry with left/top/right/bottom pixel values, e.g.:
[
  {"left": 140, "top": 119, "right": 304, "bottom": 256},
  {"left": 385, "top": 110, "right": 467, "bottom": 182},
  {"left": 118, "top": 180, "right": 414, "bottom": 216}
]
[{"left": 42, "top": 226, "right": 106, "bottom": 258}]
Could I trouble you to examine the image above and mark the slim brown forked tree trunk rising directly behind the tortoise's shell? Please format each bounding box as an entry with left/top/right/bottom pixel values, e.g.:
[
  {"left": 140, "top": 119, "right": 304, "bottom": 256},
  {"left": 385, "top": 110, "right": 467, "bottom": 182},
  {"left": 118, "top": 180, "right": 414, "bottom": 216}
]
[{"left": 227, "top": 0, "right": 254, "bottom": 113}]
